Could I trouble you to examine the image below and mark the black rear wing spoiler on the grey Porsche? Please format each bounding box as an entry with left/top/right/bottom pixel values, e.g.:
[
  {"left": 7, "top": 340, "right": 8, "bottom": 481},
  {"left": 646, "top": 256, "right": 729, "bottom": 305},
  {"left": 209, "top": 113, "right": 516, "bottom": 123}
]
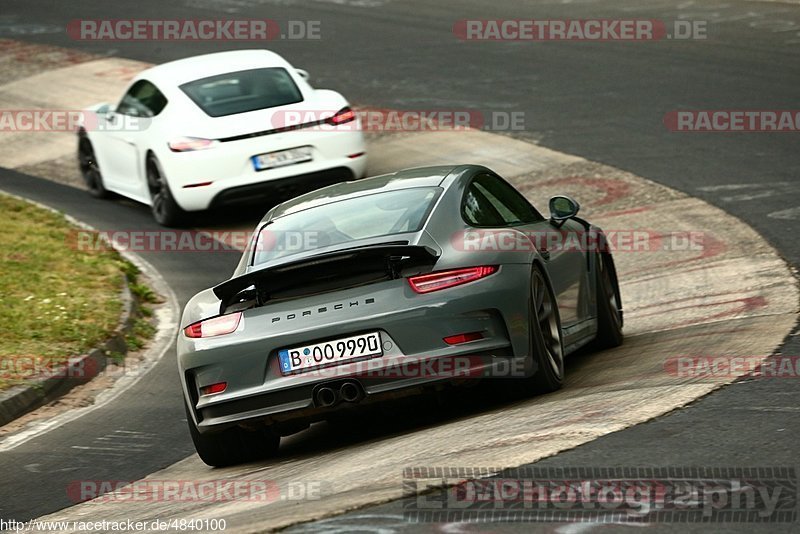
[{"left": 213, "top": 243, "right": 439, "bottom": 306}]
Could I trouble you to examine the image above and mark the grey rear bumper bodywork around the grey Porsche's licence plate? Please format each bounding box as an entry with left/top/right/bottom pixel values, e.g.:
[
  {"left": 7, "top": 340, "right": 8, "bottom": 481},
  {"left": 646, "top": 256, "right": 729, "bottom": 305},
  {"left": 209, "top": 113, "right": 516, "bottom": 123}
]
[{"left": 178, "top": 264, "right": 530, "bottom": 432}]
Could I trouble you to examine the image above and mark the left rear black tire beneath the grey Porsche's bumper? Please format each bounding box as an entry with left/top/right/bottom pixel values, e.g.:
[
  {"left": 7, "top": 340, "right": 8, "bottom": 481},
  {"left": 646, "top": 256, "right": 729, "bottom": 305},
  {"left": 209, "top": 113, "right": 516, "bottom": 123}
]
[{"left": 184, "top": 403, "right": 281, "bottom": 467}]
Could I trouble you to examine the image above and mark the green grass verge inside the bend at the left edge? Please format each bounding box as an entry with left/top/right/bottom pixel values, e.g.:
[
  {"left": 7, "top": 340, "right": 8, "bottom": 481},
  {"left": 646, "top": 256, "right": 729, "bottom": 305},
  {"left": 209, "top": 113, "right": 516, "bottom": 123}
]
[{"left": 0, "top": 194, "right": 158, "bottom": 390}]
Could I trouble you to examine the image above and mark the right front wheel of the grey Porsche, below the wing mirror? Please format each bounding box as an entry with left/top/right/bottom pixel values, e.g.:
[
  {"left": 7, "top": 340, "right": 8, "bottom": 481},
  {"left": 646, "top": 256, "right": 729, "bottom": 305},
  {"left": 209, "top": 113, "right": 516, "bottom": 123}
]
[{"left": 594, "top": 252, "right": 623, "bottom": 350}]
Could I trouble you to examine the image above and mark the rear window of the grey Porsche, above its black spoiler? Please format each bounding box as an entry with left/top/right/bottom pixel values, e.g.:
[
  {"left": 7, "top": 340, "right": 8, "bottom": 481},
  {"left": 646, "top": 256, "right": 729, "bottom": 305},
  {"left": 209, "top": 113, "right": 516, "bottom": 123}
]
[{"left": 253, "top": 187, "right": 442, "bottom": 265}]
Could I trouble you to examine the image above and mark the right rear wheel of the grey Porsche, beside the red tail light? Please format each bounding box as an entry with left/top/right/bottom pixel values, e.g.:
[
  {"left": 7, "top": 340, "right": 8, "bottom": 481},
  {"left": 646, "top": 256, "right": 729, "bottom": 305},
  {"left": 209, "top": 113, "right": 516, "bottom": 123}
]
[{"left": 526, "top": 265, "right": 564, "bottom": 394}]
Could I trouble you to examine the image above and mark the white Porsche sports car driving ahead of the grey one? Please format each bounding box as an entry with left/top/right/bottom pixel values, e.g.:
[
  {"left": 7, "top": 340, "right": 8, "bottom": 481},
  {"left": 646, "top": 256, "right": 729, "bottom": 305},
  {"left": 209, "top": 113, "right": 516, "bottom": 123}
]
[{"left": 78, "top": 50, "right": 367, "bottom": 226}]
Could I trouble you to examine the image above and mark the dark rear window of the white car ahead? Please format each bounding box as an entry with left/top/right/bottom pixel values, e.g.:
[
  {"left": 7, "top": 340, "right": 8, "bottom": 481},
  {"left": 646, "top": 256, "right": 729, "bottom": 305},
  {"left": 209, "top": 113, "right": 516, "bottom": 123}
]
[{"left": 180, "top": 67, "right": 303, "bottom": 117}]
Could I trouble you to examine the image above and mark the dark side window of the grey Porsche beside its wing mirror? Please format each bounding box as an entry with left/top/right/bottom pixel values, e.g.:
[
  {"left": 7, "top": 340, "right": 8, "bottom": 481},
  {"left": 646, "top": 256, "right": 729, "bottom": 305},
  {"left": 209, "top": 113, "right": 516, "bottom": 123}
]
[{"left": 462, "top": 174, "right": 544, "bottom": 226}]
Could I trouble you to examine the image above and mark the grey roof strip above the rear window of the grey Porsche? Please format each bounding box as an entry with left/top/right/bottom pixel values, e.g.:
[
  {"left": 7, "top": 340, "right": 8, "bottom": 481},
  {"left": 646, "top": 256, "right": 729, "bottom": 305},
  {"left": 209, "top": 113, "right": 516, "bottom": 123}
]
[{"left": 262, "top": 165, "right": 463, "bottom": 223}]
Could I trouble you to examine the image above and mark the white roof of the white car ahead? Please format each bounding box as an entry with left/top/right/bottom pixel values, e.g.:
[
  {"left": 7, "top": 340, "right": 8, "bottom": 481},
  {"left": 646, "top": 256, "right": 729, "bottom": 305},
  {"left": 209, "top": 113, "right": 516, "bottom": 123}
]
[{"left": 136, "top": 50, "right": 291, "bottom": 87}]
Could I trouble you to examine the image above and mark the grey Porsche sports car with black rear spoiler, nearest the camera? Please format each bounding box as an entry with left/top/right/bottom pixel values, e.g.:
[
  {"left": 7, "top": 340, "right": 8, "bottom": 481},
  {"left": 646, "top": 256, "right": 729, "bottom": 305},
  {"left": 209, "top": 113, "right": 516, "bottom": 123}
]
[{"left": 178, "top": 165, "right": 622, "bottom": 466}]
